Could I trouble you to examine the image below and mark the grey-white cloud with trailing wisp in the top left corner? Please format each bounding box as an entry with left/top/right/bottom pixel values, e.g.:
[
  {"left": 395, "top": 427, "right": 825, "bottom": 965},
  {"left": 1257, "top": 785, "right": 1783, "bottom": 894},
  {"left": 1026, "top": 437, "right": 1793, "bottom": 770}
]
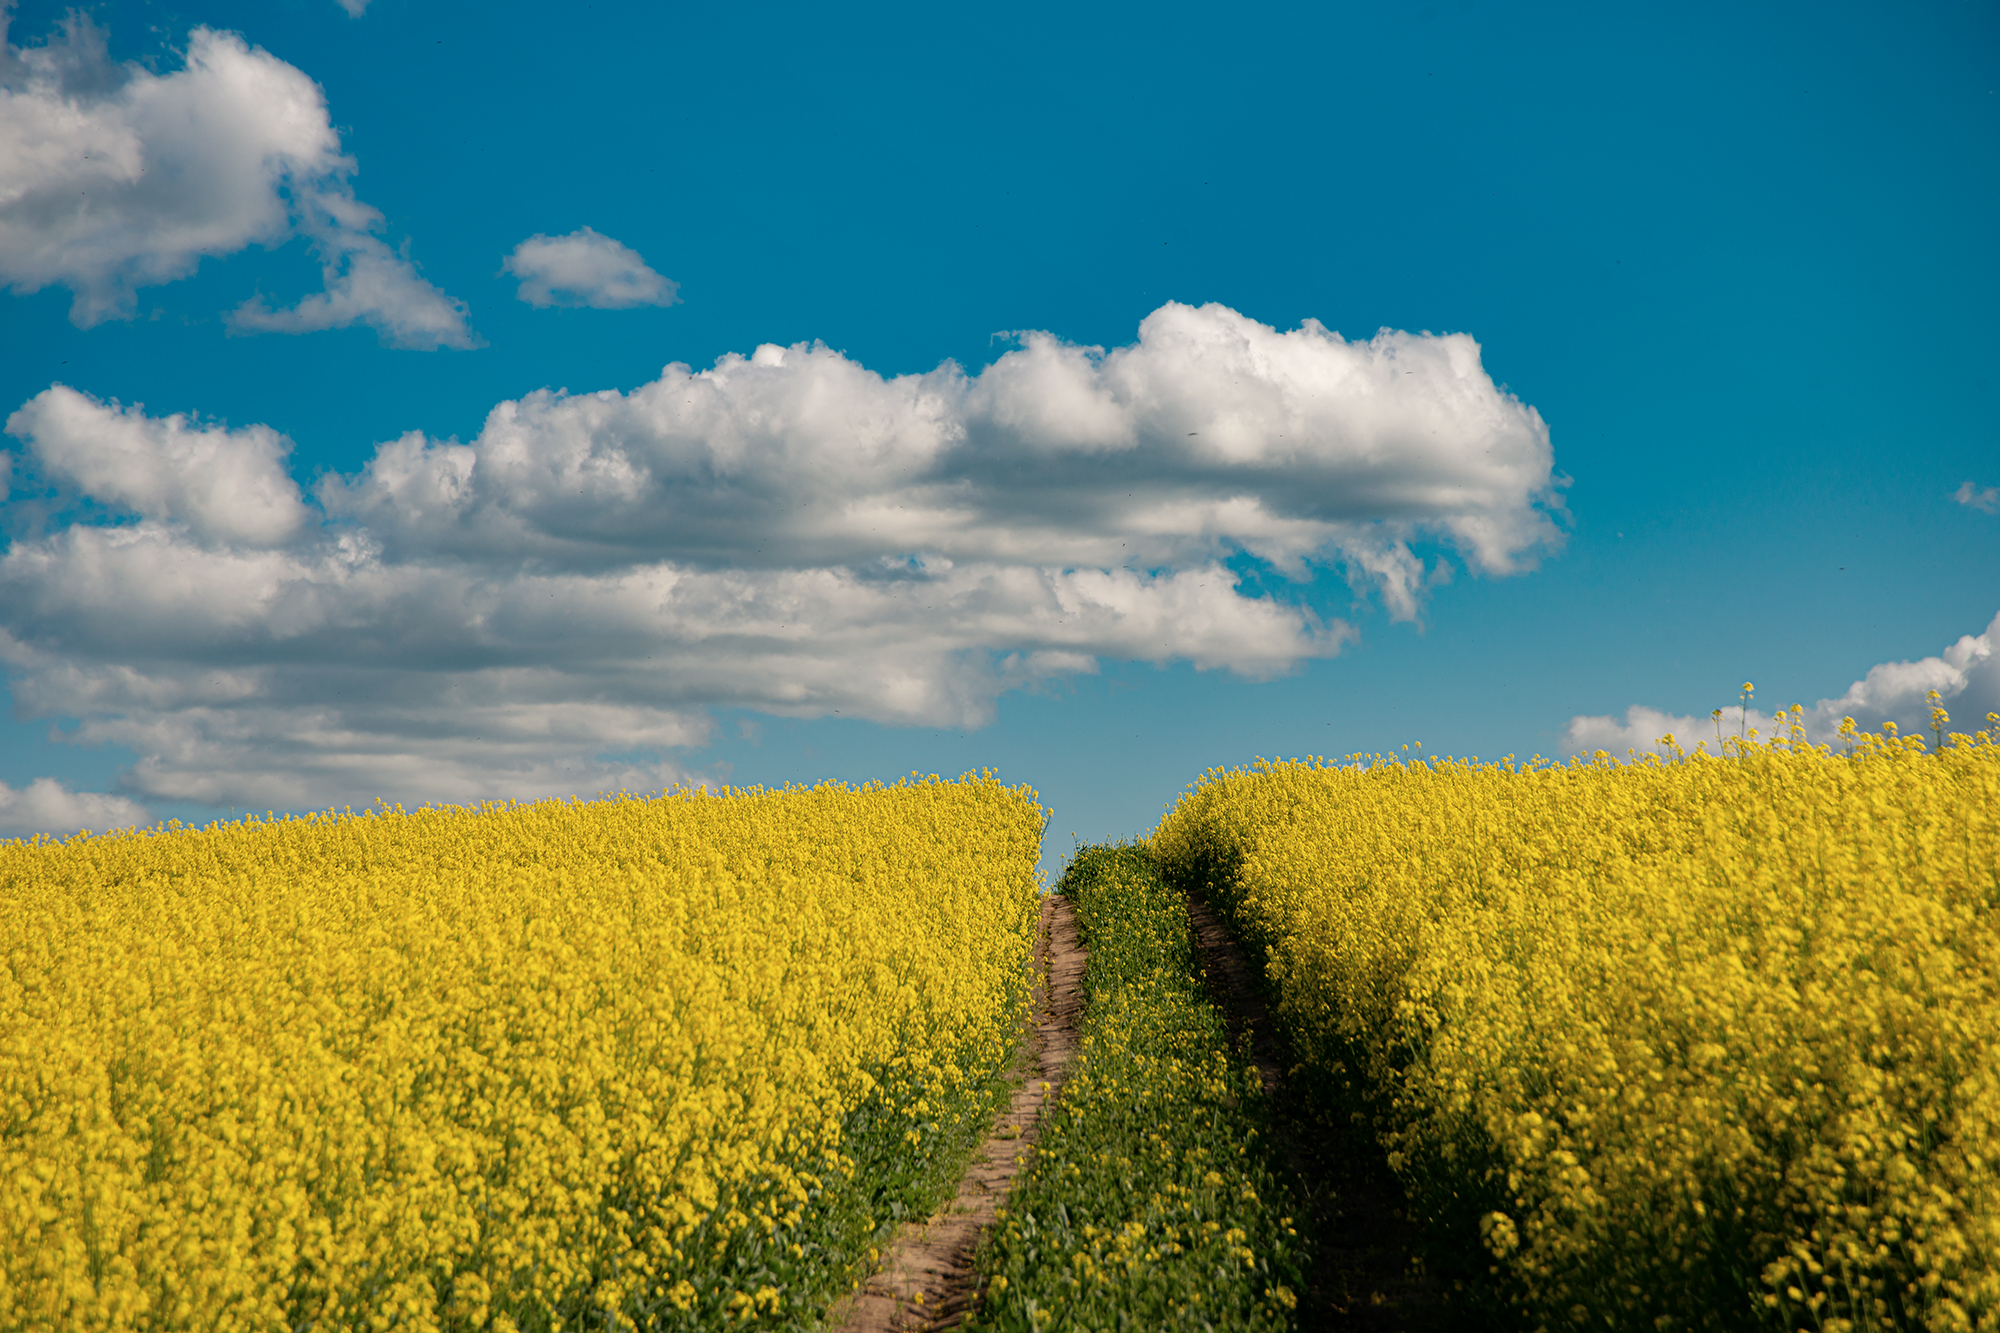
[{"left": 0, "top": 8, "right": 474, "bottom": 346}]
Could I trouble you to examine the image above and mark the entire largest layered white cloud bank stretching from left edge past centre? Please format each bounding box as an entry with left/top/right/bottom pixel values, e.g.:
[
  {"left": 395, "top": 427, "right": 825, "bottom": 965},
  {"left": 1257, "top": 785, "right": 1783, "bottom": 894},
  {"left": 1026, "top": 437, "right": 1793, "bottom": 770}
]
[{"left": 0, "top": 304, "right": 1560, "bottom": 820}]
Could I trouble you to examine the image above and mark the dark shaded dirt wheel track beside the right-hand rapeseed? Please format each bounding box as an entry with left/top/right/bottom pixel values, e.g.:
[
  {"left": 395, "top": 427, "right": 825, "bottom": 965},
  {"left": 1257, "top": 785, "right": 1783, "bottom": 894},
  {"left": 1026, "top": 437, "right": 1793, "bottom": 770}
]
[{"left": 1188, "top": 876, "right": 1480, "bottom": 1333}]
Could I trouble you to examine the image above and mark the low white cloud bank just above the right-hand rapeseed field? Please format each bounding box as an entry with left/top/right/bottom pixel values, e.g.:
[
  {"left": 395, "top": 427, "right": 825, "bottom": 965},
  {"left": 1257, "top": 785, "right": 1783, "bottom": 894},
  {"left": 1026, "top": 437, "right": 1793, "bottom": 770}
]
[{"left": 1562, "top": 614, "right": 2000, "bottom": 757}]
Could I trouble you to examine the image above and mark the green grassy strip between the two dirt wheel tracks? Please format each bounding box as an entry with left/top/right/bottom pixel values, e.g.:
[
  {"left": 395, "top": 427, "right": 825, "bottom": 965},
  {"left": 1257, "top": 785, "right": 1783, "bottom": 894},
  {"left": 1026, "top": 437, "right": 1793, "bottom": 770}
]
[{"left": 976, "top": 847, "right": 1302, "bottom": 1333}]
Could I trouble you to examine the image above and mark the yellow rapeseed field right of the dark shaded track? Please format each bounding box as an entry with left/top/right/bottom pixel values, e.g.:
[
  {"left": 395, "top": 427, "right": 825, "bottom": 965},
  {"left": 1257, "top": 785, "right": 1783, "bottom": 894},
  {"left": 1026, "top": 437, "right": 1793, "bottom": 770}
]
[{"left": 1152, "top": 715, "right": 2000, "bottom": 1331}]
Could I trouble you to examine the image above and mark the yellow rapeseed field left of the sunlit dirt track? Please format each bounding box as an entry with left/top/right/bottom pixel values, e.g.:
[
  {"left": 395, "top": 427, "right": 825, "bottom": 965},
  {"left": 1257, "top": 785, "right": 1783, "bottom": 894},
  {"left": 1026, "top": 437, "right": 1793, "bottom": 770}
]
[{"left": 0, "top": 777, "right": 1042, "bottom": 1333}]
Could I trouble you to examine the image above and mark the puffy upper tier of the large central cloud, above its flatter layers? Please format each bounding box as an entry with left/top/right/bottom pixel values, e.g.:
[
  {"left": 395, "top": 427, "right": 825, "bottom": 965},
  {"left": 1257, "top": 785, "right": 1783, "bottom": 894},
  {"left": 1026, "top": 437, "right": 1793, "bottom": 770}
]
[{"left": 320, "top": 304, "right": 1560, "bottom": 596}]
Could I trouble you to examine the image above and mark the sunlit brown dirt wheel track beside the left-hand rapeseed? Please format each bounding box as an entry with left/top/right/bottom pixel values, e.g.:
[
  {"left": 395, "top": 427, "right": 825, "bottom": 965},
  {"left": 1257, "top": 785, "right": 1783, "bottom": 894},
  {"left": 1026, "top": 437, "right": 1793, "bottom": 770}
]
[{"left": 826, "top": 897, "right": 1084, "bottom": 1333}]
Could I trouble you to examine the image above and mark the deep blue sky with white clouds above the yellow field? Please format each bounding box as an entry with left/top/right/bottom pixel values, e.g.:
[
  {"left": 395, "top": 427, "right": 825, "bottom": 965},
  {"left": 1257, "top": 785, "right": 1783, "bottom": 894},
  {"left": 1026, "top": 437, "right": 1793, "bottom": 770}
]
[{"left": 0, "top": 0, "right": 2000, "bottom": 849}]
